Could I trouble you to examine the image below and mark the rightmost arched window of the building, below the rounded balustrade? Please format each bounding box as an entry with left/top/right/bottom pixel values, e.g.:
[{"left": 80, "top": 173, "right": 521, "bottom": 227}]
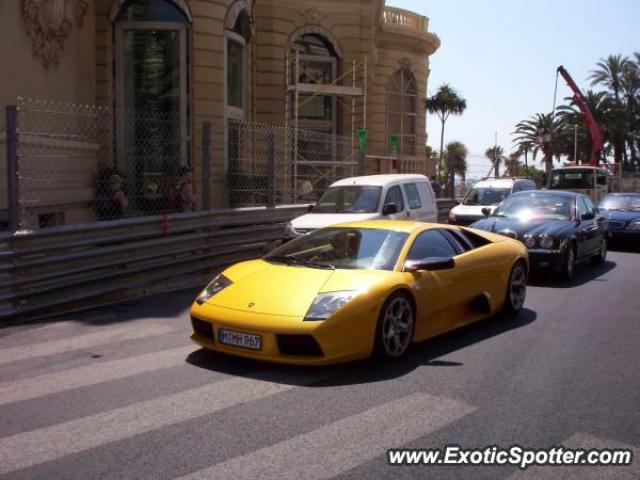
[{"left": 387, "top": 68, "right": 418, "bottom": 155}]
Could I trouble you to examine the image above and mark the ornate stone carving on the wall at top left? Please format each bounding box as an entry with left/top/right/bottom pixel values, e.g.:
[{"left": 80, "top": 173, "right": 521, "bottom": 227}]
[{"left": 20, "top": 0, "right": 89, "bottom": 68}]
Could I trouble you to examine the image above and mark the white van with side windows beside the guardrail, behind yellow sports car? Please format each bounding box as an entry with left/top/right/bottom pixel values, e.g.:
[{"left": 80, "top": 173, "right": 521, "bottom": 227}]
[{"left": 285, "top": 174, "right": 438, "bottom": 239}]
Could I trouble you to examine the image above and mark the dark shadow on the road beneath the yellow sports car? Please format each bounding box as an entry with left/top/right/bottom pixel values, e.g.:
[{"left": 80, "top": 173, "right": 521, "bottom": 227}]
[{"left": 187, "top": 308, "right": 537, "bottom": 387}]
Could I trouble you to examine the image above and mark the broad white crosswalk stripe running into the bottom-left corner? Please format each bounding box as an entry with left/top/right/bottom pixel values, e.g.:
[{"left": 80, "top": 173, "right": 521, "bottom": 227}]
[{"left": 0, "top": 374, "right": 322, "bottom": 475}]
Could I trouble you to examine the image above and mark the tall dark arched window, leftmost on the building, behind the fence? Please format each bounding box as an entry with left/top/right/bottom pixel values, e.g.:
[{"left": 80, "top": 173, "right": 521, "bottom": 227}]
[{"left": 111, "top": 0, "right": 191, "bottom": 212}]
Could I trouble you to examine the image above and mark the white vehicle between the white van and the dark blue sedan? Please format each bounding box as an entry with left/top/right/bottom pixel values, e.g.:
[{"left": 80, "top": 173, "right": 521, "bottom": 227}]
[{"left": 449, "top": 178, "right": 536, "bottom": 225}]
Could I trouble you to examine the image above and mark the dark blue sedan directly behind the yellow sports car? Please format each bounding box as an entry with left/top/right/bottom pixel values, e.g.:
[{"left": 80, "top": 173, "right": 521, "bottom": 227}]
[{"left": 471, "top": 190, "right": 608, "bottom": 278}]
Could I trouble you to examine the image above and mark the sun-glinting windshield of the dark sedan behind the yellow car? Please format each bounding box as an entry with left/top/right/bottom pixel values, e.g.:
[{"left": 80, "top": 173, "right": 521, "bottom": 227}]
[{"left": 493, "top": 192, "right": 573, "bottom": 221}]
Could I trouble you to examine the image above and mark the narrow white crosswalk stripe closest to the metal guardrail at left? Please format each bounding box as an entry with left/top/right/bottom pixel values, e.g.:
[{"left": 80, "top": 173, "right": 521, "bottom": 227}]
[{"left": 0, "top": 321, "right": 176, "bottom": 364}]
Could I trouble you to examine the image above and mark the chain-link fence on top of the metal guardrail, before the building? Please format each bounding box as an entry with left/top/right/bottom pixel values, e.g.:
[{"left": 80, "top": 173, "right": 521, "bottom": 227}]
[{"left": 0, "top": 100, "right": 362, "bottom": 229}]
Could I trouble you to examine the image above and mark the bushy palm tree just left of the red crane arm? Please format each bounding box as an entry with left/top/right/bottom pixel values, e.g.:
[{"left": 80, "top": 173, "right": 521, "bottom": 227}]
[{"left": 512, "top": 113, "right": 564, "bottom": 174}]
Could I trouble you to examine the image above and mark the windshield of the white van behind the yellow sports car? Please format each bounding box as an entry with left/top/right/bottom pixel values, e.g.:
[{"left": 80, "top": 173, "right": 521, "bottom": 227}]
[{"left": 313, "top": 185, "right": 382, "bottom": 213}]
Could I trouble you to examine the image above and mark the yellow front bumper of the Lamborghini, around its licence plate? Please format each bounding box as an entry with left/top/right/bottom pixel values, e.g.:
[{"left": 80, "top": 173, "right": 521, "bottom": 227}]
[{"left": 191, "top": 304, "right": 376, "bottom": 365}]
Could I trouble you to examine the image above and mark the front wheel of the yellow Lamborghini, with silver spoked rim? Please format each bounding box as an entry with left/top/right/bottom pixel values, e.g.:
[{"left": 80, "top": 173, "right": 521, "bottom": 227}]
[{"left": 373, "top": 293, "right": 416, "bottom": 360}]
